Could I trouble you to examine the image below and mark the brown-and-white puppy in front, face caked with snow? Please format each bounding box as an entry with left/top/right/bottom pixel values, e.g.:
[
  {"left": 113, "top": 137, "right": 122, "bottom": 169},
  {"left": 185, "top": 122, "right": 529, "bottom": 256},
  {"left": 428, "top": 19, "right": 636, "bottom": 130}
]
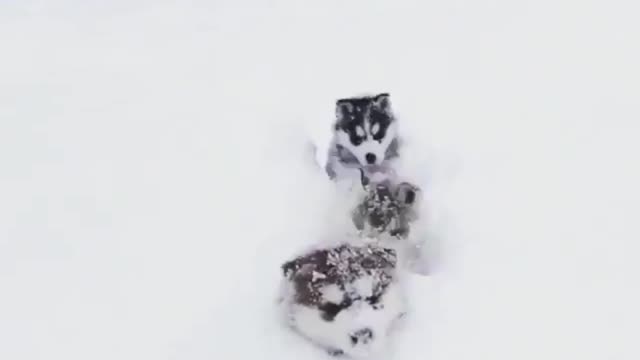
[{"left": 281, "top": 244, "right": 405, "bottom": 358}]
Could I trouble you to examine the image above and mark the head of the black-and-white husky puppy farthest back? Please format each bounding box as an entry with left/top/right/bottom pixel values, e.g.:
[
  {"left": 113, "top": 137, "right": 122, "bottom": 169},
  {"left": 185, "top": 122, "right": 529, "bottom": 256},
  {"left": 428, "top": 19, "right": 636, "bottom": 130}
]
[{"left": 334, "top": 93, "right": 397, "bottom": 166}]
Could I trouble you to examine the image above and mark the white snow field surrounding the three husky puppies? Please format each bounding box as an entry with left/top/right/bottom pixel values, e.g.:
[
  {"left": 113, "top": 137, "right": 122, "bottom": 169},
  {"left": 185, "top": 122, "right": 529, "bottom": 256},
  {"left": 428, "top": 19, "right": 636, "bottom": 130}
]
[{"left": 0, "top": 0, "right": 640, "bottom": 360}]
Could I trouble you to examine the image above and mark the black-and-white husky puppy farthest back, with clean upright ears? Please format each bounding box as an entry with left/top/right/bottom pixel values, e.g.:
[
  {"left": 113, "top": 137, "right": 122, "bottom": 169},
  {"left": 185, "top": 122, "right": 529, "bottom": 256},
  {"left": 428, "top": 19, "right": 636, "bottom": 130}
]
[{"left": 325, "top": 93, "right": 400, "bottom": 186}]
